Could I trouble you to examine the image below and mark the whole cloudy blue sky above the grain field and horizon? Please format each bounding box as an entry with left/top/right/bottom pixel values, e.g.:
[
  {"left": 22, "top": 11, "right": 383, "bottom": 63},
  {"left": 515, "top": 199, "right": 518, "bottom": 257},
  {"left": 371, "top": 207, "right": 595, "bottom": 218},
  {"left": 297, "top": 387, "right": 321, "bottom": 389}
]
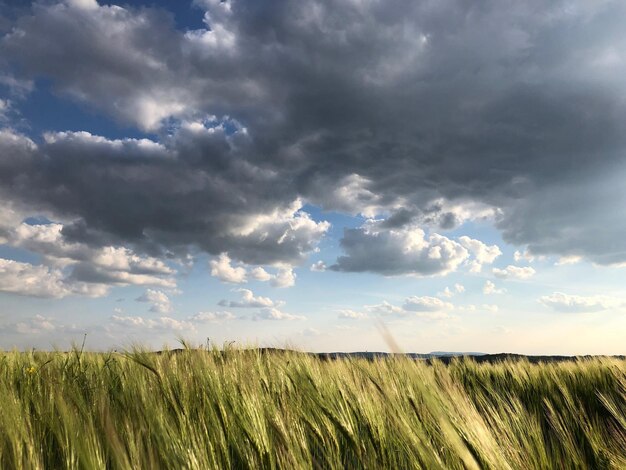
[{"left": 0, "top": 0, "right": 626, "bottom": 354}]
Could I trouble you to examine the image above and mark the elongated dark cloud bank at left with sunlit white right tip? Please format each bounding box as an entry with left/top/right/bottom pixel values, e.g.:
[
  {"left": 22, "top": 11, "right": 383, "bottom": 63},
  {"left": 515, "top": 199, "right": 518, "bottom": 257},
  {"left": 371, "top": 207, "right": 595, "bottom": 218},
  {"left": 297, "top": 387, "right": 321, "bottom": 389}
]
[{"left": 0, "top": 124, "right": 328, "bottom": 266}]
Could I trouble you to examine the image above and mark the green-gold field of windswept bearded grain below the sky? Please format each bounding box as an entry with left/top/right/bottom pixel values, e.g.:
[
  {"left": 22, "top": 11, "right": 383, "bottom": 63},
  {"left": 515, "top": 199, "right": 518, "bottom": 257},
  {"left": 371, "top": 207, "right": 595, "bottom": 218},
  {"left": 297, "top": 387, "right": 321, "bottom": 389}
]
[{"left": 0, "top": 349, "right": 626, "bottom": 469}]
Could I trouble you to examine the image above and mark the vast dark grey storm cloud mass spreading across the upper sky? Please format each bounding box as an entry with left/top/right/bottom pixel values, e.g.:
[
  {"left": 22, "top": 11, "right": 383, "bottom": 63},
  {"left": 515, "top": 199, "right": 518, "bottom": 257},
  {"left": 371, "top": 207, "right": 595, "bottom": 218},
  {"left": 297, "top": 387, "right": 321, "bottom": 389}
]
[{"left": 0, "top": 0, "right": 626, "bottom": 273}]
